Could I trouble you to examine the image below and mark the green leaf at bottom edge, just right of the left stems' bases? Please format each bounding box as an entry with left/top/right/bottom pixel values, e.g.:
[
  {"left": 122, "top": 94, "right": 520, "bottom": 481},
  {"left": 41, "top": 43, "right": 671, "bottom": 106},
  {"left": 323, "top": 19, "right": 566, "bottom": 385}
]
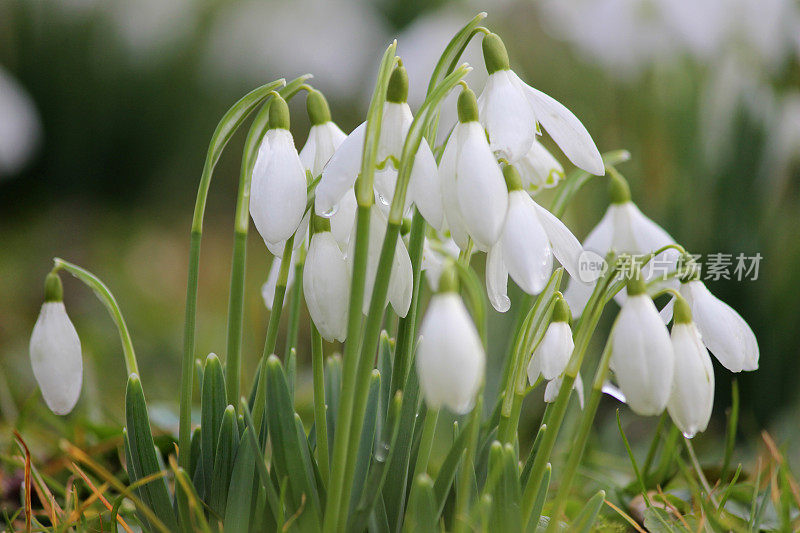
[{"left": 224, "top": 427, "right": 259, "bottom": 533}]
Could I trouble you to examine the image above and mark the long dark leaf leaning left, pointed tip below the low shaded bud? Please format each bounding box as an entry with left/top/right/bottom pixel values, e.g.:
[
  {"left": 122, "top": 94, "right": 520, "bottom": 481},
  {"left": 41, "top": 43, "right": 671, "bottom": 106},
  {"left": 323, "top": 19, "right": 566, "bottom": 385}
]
[{"left": 266, "top": 355, "right": 322, "bottom": 530}]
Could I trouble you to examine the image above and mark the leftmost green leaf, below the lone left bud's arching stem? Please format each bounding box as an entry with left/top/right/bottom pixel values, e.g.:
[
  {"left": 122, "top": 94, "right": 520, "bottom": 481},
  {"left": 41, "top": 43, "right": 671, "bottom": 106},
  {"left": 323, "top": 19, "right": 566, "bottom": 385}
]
[{"left": 125, "top": 374, "right": 178, "bottom": 530}]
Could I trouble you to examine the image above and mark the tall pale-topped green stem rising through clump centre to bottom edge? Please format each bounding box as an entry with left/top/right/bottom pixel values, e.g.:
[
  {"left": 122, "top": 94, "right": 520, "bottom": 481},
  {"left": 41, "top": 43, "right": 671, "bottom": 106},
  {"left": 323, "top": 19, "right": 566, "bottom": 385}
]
[{"left": 323, "top": 42, "right": 397, "bottom": 533}]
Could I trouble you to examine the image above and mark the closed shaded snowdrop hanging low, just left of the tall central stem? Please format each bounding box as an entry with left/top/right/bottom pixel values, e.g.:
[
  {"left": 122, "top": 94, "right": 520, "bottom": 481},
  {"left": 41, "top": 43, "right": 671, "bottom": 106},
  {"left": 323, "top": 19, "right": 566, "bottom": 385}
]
[{"left": 303, "top": 217, "right": 350, "bottom": 342}]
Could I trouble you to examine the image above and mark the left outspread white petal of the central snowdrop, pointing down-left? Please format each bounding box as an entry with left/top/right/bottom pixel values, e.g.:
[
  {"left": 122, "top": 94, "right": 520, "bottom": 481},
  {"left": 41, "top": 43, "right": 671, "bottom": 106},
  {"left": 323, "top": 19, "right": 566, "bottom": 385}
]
[{"left": 314, "top": 122, "right": 367, "bottom": 216}]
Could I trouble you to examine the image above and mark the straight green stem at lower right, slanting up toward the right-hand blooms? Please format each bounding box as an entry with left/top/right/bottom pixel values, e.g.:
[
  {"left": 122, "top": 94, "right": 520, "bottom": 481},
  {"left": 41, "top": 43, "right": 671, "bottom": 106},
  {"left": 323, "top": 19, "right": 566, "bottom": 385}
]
[{"left": 547, "top": 338, "right": 611, "bottom": 531}]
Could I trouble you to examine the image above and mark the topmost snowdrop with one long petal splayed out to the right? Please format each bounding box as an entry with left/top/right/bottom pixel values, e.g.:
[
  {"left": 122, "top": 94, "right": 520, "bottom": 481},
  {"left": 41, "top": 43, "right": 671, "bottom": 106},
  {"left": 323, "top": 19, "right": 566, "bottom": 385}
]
[{"left": 478, "top": 33, "right": 605, "bottom": 175}]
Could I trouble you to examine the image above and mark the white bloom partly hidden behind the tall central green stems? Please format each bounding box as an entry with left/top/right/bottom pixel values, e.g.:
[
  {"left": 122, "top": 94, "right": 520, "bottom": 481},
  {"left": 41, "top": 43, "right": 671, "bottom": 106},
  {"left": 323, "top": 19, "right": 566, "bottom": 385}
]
[{"left": 347, "top": 205, "right": 414, "bottom": 317}]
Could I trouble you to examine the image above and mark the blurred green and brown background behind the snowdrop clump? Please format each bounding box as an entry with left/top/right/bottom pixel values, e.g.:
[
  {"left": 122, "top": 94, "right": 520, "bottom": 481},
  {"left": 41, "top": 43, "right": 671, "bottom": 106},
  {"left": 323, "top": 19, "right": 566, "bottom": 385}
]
[{"left": 0, "top": 0, "right": 800, "bottom": 470}]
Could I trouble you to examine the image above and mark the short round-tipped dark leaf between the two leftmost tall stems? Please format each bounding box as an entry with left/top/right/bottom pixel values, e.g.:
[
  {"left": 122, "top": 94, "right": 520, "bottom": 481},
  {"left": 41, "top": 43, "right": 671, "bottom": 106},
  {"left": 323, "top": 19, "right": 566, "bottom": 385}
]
[{"left": 200, "top": 353, "right": 227, "bottom": 502}]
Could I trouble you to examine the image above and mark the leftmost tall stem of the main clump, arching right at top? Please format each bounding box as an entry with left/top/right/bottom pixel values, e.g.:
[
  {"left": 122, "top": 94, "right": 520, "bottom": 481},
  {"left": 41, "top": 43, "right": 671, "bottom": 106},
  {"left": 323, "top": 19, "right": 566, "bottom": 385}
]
[{"left": 178, "top": 79, "right": 286, "bottom": 469}]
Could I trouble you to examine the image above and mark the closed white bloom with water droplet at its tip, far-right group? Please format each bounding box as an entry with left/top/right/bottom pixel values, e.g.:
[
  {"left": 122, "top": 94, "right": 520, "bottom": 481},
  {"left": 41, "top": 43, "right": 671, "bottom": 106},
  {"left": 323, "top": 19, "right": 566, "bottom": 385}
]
[{"left": 667, "top": 298, "right": 714, "bottom": 438}]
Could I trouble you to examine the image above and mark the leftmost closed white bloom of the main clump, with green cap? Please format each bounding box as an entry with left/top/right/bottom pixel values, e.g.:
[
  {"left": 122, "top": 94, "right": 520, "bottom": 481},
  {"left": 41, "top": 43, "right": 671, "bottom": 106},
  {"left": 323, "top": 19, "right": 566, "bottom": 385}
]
[{"left": 250, "top": 95, "right": 306, "bottom": 243}]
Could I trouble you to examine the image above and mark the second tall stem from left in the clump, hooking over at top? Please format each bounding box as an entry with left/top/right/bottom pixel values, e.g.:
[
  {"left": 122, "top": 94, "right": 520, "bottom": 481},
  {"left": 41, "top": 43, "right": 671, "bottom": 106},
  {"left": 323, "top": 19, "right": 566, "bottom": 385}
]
[{"left": 225, "top": 74, "right": 311, "bottom": 406}]
